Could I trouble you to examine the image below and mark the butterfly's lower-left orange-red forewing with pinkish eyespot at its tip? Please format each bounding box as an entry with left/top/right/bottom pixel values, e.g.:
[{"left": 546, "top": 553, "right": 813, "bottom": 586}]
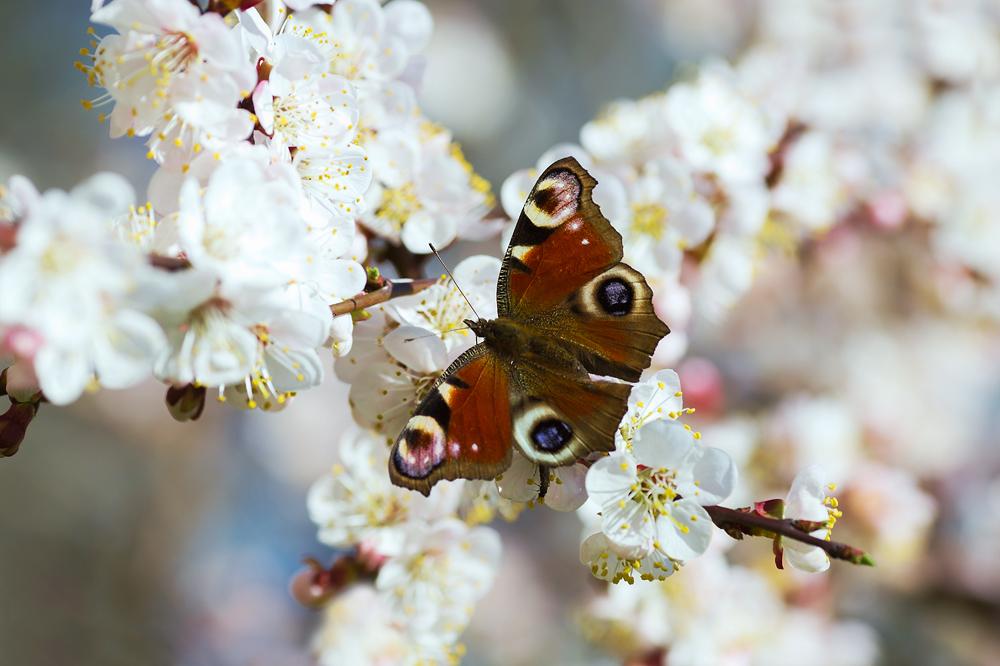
[{"left": 389, "top": 345, "right": 511, "bottom": 495}]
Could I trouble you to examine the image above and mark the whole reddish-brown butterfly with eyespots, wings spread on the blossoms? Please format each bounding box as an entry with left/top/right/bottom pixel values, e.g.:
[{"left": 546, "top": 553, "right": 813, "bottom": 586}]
[{"left": 389, "top": 157, "right": 670, "bottom": 495}]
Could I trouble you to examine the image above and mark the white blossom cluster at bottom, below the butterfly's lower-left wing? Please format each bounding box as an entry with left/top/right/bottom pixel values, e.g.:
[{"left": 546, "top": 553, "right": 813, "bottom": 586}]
[{"left": 309, "top": 422, "right": 501, "bottom": 665}]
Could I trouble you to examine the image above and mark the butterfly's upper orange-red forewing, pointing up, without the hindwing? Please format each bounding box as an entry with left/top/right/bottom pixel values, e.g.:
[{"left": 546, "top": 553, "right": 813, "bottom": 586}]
[{"left": 497, "top": 157, "right": 622, "bottom": 320}]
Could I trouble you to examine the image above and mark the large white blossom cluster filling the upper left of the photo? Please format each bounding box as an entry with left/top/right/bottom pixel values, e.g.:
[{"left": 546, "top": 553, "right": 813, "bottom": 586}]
[{"left": 0, "top": 0, "right": 496, "bottom": 410}]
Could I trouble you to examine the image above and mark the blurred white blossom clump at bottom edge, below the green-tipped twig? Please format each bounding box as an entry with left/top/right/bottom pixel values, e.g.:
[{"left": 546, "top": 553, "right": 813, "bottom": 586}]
[{"left": 577, "top": 547, "right": 878, "bottom": 666}]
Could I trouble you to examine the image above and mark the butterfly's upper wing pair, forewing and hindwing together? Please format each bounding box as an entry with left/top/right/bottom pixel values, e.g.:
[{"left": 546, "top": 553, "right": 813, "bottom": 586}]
[{"left": 497, "top": 157, "right": 670, "bottom": 381}]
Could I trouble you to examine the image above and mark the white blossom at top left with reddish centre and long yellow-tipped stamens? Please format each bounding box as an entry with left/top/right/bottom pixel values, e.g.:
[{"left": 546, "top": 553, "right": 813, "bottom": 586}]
[{"left": 83, "top": 0, "right": 256, "bottom": 169}]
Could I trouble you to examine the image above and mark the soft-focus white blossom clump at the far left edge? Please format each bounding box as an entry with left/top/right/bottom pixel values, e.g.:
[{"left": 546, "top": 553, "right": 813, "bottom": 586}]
[{"left": 0, "top": 174, "right": 164, "bottom": 404}]
